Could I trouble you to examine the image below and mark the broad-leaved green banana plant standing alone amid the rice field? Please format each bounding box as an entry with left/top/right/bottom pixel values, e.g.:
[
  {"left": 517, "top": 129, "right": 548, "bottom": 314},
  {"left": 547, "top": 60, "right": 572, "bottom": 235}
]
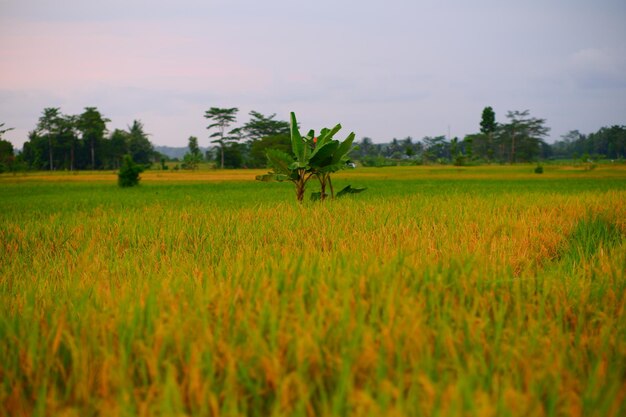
[{"left": 257, "top": 112, "right": 363, "bottom": 201}]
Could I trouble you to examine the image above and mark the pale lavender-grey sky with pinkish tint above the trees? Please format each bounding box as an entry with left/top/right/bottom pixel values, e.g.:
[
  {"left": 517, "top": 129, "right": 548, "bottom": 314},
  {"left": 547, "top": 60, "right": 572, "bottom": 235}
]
[{"left": 0, "top": 0, "right": 626, "bottom": 148}]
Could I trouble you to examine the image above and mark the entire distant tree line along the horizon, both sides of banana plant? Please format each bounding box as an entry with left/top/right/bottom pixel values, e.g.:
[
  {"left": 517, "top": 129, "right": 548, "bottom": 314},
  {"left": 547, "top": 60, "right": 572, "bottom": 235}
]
[{"left": 0, "top": 107, "right": 626, "bottom": 172}]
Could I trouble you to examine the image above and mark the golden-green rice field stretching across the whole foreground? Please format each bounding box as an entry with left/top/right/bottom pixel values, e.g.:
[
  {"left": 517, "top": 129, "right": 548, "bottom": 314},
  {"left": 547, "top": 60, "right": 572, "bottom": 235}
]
[{"left": 0, "top": 165, "right": 626, "bottom": 416}]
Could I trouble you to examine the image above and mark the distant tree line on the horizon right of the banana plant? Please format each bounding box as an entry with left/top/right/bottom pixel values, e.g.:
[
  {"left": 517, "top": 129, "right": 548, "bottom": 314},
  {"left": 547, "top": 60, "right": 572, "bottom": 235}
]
[{"left": 351, "top": 107, "right": 626, "bottom": 166}]
